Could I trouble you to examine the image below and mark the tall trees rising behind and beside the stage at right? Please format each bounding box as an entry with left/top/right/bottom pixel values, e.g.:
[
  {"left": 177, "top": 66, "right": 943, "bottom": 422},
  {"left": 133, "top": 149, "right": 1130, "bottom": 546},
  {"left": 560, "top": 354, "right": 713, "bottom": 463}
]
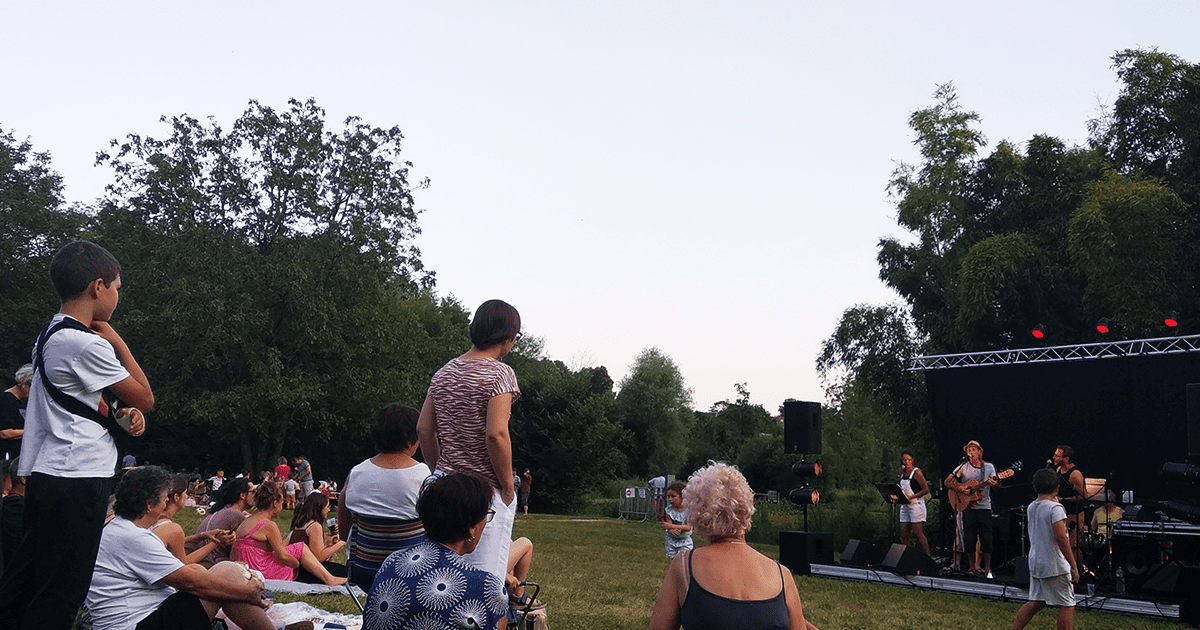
[{"left": 817, "top": 49, "right": 1200, "bottom": 484}]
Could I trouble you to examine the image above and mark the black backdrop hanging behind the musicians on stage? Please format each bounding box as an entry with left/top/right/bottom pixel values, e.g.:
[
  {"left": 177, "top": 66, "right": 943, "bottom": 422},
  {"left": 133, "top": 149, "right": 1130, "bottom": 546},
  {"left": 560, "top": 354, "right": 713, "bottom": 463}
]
[{"left": 925, "top": 353, "right": 1200, "bottom": 508}]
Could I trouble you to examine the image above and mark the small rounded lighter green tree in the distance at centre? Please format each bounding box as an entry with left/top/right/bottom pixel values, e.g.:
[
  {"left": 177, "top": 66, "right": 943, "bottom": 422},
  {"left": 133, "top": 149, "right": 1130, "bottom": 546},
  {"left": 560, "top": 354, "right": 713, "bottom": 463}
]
[{"left": 613, "top": 348, "right": 692, "bottom": 476}]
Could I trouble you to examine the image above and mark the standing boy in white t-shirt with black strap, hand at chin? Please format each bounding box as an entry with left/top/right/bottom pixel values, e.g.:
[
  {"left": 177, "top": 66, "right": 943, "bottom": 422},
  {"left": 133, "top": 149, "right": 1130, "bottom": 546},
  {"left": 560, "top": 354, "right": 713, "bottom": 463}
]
[{"left": 0, "top": 241, "right": 154, "bottom": 630}]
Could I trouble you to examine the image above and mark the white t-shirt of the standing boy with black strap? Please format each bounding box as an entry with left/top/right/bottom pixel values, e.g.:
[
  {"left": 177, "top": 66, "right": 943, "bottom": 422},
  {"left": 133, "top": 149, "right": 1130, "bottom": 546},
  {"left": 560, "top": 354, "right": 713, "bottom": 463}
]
[{"left": 17, "top": 313, "right": 130, "bottom": 478}]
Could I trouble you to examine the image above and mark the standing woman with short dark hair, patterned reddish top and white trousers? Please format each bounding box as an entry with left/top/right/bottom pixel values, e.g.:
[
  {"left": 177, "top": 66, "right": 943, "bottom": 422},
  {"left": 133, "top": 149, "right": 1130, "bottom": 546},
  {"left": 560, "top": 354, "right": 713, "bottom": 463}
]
[{"left": 418, "top": 300, "right": 521, "bottom": 581}]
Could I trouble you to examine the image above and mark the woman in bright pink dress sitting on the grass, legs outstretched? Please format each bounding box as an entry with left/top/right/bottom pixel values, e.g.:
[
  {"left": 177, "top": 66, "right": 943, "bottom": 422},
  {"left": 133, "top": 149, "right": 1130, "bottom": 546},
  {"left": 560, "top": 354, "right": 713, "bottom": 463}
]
[{"left": 233, "top": 481, "right": 346, "bottom": 586}]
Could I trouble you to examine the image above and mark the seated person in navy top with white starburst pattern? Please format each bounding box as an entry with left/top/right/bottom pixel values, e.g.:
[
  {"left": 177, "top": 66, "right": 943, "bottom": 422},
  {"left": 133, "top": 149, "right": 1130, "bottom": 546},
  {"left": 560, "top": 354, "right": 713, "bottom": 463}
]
[{"left": 362, "top": 473, "right": 508, "bottom": 630}]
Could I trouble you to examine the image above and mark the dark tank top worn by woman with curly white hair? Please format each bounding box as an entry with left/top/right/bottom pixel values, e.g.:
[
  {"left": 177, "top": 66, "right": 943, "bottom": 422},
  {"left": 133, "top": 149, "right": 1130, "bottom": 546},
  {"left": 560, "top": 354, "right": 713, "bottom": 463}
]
[{"left": 679, "top": 552, "right": 788, "bottom": 630}]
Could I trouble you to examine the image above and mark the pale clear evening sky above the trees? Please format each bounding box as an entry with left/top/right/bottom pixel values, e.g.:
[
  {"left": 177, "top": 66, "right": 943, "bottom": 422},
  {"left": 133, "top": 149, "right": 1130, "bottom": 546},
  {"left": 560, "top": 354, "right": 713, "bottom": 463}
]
[{"left": 0, "top": 0, "right": 1200, "bottom": 413}]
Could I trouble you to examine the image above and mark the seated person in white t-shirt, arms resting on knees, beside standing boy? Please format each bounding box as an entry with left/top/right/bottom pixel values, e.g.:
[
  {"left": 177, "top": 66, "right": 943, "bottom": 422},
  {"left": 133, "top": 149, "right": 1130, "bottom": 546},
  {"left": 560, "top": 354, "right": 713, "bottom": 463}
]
[{"left": 86, "top": 466, "right": 275, "bottom": 630}]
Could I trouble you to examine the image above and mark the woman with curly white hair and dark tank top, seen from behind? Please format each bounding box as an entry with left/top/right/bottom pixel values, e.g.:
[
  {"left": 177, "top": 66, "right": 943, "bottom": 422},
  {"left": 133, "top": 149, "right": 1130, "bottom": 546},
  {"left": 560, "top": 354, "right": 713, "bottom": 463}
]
[{"left": 649, "top": 463, "right": 816, "bottom": 630}]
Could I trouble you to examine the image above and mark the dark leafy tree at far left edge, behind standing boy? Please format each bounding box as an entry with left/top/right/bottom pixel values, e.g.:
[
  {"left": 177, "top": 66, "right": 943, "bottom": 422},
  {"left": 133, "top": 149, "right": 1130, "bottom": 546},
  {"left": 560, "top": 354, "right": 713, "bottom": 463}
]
[{"left": 0, "top": 130, "right": 84, "bottom": 374}]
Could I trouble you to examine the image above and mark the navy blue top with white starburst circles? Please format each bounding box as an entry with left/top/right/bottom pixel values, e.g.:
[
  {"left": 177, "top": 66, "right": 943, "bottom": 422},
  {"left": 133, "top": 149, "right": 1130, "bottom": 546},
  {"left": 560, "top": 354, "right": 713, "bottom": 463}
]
[{"left": 362, "top": 541, "right": 508, "bottom": 630}]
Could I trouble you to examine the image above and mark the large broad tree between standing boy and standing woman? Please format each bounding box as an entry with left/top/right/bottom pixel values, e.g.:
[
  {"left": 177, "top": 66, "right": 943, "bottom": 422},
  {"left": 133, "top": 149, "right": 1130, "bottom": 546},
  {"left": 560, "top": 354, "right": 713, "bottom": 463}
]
[{"left": 94, "top": 100, "right": 453, "bottom": 470}]
